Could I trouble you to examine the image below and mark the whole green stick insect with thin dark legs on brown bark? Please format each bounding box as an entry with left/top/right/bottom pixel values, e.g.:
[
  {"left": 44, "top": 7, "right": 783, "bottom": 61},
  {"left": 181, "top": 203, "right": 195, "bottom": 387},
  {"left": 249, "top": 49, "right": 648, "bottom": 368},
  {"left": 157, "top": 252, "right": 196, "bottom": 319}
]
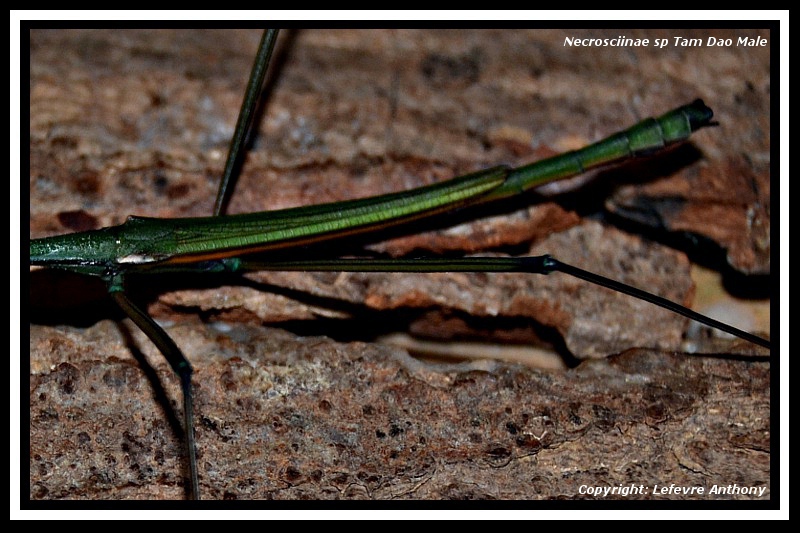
[{"left": 30, "top": 33, "right": 770, "bottom": 498}]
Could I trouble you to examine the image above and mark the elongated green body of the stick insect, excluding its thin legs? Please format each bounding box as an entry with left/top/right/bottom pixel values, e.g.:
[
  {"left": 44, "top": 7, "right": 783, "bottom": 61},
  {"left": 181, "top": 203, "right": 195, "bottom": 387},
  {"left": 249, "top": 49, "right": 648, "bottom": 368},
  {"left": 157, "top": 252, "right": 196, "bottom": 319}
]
[{"left": 30, "top": 100, "right": 713, "bottom": 277}]
